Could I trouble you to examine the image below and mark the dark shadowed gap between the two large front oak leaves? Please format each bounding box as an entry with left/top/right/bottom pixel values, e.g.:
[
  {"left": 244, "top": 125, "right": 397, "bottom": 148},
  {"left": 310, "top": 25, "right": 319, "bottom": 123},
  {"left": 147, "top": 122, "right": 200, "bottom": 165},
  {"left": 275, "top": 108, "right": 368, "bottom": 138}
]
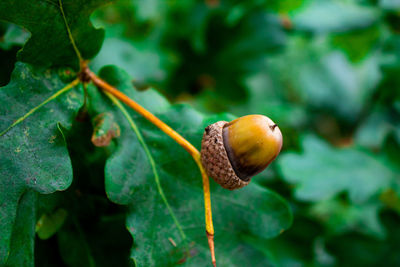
[{"left": 48, "top": 117, "right": 132, "bottom": 267}]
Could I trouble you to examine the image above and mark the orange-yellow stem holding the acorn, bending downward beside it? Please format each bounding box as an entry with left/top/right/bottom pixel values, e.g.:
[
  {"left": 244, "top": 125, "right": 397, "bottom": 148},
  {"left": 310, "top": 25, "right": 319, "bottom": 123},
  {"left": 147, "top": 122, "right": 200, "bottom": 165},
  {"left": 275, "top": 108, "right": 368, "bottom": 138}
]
[{"left": 83, "top": 67, "right": 216, "bottom": 266}]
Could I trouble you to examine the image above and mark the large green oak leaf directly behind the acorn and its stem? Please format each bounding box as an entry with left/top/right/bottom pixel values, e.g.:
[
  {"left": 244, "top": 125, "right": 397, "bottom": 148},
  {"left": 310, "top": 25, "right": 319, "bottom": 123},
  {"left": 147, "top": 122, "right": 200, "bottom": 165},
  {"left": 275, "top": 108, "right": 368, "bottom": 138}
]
[{"left": 89, "top": 67, "right": 291, "bottom": 266}]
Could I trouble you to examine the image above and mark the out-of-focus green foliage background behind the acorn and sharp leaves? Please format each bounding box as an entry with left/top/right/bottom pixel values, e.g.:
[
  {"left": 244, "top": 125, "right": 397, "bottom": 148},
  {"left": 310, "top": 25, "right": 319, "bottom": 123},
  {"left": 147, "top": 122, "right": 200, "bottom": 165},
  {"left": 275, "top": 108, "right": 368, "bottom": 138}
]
[{"left": 0, "top": 0, "right": 400, "bottom": 266}]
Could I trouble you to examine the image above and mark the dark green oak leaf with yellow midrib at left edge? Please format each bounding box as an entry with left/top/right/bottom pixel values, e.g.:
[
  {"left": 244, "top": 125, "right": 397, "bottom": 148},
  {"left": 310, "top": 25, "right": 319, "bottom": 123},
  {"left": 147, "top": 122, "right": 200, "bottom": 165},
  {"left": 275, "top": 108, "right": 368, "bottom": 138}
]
[{"left": 0, "top": 63, "right": 82, "bottom": 264}]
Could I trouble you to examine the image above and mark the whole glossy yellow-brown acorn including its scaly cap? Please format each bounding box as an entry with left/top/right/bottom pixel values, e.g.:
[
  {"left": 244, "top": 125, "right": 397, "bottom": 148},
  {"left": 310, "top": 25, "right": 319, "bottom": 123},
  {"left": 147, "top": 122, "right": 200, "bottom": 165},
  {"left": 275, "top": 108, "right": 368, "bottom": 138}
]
[{"left": 201, "top": 115, "right": 282, "bottom": 190}]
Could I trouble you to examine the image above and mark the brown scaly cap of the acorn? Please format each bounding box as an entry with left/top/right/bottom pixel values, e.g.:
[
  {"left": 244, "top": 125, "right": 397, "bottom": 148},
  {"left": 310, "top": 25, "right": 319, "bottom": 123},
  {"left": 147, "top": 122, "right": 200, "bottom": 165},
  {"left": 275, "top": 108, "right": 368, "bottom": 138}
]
[{"left": 201, "top": 121, "right": 250, "bottom": 190}]
